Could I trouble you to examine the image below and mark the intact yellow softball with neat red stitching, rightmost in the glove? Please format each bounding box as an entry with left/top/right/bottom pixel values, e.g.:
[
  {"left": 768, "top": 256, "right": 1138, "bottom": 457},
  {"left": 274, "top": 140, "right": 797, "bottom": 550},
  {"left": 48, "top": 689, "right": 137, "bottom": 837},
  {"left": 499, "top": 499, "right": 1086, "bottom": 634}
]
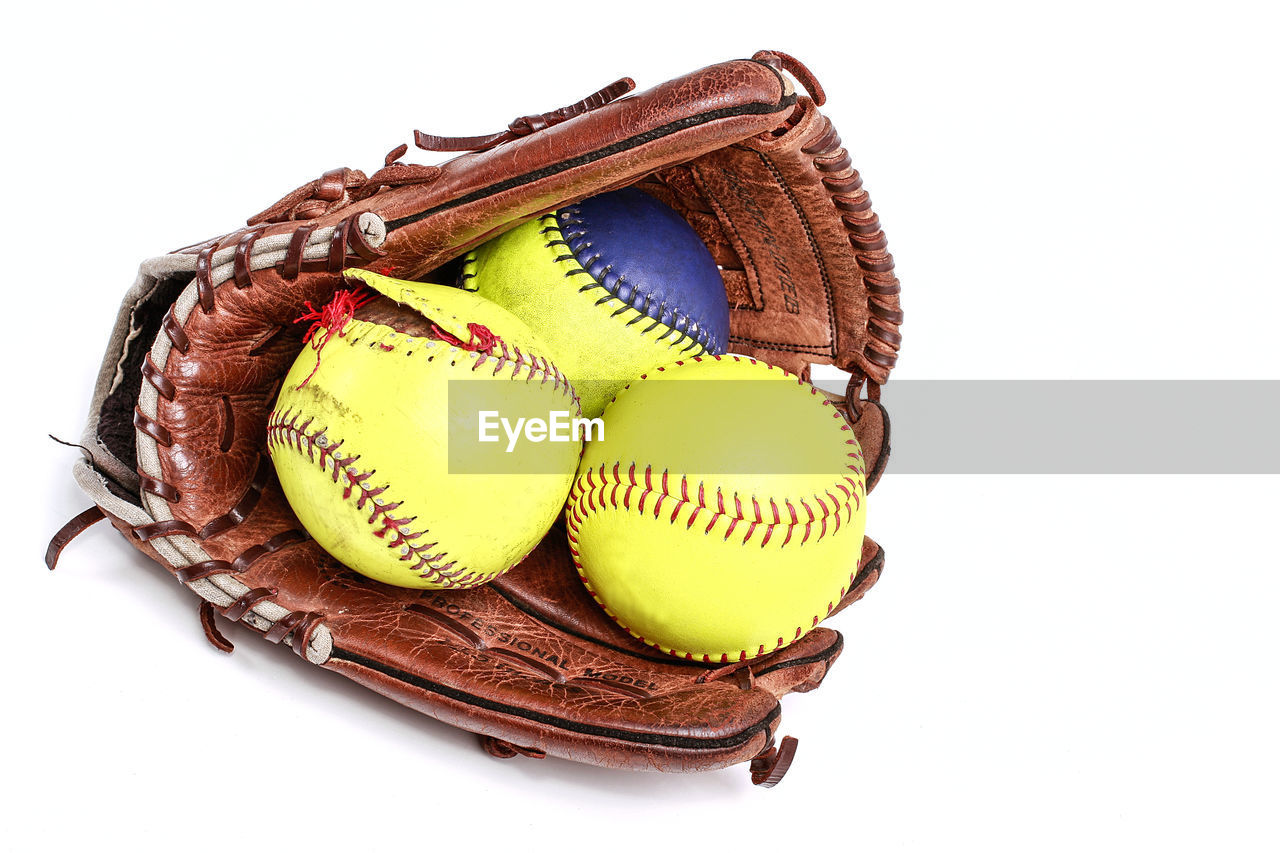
[{"left": 566, "top": 356, "right": 867, "bottom": 662}]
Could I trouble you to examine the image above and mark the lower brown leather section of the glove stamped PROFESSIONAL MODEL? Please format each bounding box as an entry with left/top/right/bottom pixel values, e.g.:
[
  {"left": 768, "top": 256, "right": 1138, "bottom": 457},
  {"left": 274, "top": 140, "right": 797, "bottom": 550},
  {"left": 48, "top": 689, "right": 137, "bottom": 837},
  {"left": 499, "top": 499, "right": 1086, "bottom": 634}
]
[{"left": 114, "top": 482, "right": 878, "bottom": 771}]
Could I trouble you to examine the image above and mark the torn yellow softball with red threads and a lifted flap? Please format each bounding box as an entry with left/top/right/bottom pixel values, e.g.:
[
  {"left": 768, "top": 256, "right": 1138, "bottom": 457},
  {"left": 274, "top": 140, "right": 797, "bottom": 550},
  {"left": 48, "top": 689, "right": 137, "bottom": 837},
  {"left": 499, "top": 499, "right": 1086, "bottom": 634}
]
[{"left": 266, "top": 272, "right": 581, "bottom": 589}]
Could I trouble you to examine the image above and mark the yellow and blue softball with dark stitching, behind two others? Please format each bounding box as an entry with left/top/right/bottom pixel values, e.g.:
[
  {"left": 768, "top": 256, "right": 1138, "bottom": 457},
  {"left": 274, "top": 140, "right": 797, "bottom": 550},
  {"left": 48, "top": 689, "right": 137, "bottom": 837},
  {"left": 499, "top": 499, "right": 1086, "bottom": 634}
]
[{"left": 460, "top": 187, "right": 730, "bottom": 418}]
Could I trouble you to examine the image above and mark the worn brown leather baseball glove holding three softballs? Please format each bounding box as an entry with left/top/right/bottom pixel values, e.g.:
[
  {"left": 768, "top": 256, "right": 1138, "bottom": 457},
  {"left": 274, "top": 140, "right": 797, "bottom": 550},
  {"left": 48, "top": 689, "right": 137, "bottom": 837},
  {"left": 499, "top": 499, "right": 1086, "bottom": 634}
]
[{"left": 47, "top": 51, "right": 902, "bottom": 785}]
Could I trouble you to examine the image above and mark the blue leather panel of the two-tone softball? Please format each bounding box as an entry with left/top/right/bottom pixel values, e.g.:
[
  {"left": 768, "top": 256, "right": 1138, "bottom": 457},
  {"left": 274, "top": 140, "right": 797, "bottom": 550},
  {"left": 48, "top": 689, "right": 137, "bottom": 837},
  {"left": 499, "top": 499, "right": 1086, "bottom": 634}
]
[{"left": 558, "top": 187, "right": 728, "bottom": 355}]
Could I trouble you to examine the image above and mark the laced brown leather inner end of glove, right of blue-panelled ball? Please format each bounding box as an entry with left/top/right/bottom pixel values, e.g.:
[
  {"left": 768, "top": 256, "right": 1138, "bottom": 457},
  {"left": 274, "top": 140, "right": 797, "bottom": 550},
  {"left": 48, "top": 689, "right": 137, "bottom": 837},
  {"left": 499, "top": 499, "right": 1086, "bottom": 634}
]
[{"left": 641, "top": 97, "right": 902, "bottom": 384}]
